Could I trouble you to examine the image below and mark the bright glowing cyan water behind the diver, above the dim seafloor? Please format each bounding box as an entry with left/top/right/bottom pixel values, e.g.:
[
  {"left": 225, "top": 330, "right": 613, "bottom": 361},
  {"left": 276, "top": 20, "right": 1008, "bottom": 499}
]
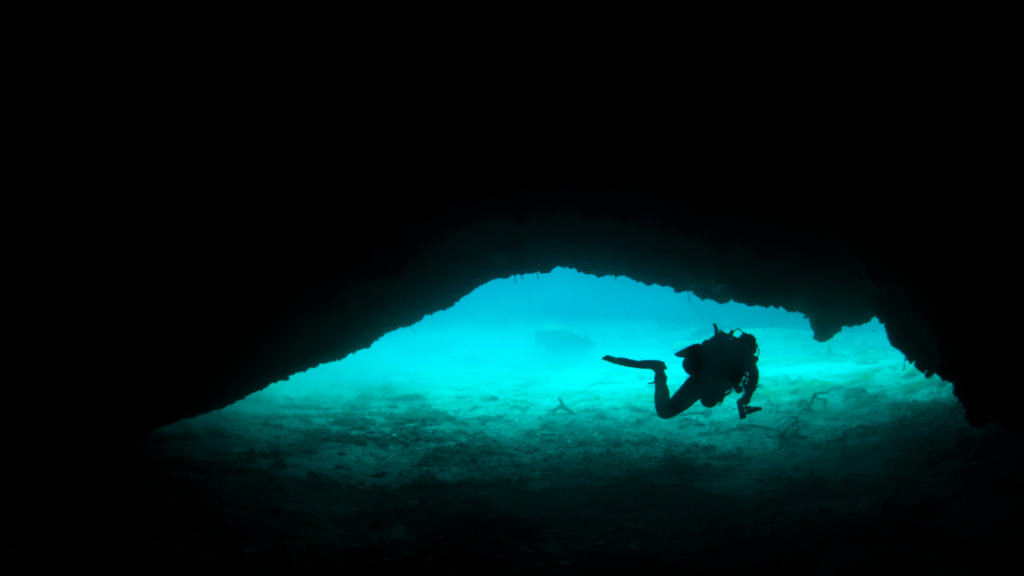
[{"left": 222, "top": 269, "right": 948, "bottom": 428}]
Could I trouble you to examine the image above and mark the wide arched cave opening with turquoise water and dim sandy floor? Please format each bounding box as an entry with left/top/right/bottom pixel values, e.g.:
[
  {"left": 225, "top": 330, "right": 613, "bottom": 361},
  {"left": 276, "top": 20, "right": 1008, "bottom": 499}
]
[{"left": 128, "top": 269, "right": 1004, "bottom": 572}]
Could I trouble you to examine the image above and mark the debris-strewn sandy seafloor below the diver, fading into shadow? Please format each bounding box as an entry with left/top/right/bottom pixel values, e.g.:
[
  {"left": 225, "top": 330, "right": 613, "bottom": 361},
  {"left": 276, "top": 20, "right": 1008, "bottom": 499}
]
[{"left": 127, "top": 322, "right": 1024, "bottom": 574}]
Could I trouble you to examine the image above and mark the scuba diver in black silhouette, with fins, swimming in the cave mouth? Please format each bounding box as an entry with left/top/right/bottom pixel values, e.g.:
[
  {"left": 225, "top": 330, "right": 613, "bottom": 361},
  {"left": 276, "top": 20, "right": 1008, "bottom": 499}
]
[{"left": 601, "top": 324, "right": 761, "bottom": 419}]
